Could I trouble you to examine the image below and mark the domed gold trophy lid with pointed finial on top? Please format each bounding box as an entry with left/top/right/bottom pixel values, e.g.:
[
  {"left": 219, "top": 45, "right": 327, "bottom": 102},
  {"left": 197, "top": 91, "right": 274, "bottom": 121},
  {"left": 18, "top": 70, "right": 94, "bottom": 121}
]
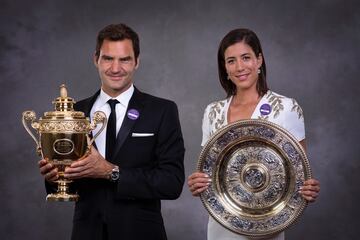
[{"left": 44, "top": 84, "right": 85, "bottom": 118}]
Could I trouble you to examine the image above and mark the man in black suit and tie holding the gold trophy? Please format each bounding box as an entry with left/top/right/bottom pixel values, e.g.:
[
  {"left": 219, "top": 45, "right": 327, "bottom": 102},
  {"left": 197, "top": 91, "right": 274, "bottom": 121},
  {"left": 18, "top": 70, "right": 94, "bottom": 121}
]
[{"left": 39, "top": 24, "right": 185, "bottom": 240}]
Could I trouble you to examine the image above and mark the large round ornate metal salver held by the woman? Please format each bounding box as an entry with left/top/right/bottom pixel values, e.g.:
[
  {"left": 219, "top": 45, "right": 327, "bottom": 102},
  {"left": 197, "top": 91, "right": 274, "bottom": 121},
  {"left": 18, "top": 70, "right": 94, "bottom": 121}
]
[{"left": 197, "top": 119, "right": 311, "bottom": 237}]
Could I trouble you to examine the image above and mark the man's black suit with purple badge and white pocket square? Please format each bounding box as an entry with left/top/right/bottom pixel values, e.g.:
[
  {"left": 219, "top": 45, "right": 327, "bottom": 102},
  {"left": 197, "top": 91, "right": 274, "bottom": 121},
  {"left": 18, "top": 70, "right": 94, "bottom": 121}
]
[{"left": 46, "top": 88, "right": 185, "bottom": 240}]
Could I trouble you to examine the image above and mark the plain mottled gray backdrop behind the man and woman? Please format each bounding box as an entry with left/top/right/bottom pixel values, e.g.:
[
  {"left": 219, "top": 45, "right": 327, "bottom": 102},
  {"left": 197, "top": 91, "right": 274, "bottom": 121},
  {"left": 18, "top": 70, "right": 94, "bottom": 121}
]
[{"left": 0, "top": 0, "right": 360, "bottom": 240}]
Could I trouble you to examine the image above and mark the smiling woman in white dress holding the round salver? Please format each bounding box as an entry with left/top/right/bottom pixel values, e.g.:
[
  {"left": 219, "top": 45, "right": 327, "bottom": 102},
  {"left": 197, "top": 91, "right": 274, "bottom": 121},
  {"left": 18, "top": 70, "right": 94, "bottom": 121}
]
[{"left": 188, "top": 29, "right": 320, "bottom": 240}]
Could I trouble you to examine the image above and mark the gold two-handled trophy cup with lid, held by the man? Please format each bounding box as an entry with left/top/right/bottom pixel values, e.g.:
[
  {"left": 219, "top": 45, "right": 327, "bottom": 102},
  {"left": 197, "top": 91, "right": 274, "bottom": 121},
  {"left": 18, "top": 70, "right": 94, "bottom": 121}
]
[{"left": 22, "top": 84, "right": 106, "bottom": 201}]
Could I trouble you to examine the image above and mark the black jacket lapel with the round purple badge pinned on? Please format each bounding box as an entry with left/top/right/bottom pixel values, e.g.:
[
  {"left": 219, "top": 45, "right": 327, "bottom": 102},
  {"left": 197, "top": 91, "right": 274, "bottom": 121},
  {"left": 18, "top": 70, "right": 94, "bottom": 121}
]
[{"left": 111, "top": 88, "right": 144, "bottom": 162}]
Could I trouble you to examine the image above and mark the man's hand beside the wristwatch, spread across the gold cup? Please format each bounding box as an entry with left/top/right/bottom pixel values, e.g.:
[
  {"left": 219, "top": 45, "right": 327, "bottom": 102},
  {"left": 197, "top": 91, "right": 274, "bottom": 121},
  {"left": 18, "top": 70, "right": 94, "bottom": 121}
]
[{"left": 64, "top": 146, "right": 114, "bottom": 179}]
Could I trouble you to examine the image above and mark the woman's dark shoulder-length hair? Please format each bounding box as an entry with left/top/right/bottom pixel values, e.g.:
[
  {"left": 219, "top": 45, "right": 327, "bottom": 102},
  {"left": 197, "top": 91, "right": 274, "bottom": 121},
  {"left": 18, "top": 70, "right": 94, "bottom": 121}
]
[{"left": 218, "top": 28, "right": 268, "bottom": 97}]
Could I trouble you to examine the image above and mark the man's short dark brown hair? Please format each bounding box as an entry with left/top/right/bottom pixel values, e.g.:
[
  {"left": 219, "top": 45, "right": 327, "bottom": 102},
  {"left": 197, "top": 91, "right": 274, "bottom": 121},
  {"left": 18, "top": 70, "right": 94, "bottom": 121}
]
[{"left": 95, "top": 23, "right": 140, "bottom": 63}]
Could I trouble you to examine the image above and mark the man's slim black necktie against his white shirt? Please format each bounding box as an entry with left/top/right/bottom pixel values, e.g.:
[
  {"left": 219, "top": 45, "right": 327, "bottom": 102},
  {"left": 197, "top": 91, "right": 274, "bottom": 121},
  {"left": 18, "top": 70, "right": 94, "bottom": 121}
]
[{"left": 105, "top": 99, "right": 119, "bottom": 161}]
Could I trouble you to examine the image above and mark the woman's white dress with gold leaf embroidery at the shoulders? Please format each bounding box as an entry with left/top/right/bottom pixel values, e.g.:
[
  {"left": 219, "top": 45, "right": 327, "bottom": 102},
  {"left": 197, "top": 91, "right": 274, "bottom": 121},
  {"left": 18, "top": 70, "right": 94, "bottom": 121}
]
[{"left": 201, "top": 90, "right": 305, "bottom": 240}]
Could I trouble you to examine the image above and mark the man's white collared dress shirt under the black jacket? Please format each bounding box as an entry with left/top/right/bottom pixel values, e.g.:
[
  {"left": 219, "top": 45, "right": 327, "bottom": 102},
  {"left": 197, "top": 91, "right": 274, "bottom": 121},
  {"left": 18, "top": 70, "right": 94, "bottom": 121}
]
[{"left": 90, "top": 84, "right": 134, "bottom": 158}]
